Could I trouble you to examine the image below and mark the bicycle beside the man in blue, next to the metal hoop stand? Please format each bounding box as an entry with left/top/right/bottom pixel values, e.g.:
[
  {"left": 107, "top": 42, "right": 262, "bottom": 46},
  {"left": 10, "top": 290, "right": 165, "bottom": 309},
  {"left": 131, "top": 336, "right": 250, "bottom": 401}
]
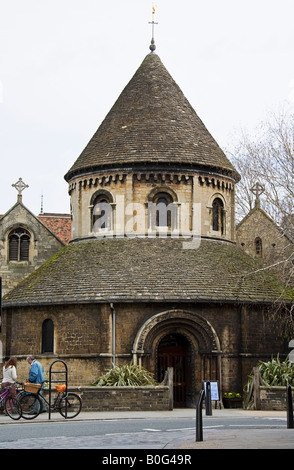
[{"left": 17, "top": 383, "right": 82, "bottom": 419}]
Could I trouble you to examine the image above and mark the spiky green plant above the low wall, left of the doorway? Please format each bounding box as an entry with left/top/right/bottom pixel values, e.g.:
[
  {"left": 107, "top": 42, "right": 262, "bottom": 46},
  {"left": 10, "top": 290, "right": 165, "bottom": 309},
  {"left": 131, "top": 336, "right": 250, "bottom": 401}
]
[{"left": 92, "top": 363, "right": 157, "bottom": 387}]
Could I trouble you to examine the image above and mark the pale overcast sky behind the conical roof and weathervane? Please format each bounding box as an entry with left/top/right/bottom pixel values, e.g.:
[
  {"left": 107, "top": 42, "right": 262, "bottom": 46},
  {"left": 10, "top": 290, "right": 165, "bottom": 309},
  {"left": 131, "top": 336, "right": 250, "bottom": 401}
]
[{"left": 0, "top": 0, "right": 294, "bottom": 215}]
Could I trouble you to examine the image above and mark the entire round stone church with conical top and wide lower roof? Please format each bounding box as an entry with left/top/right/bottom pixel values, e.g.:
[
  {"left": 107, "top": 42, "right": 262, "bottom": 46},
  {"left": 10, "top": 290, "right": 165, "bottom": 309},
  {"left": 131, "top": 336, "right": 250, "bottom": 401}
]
[{"left": 0, "top": 48, "right": 292, "bottom": 407}]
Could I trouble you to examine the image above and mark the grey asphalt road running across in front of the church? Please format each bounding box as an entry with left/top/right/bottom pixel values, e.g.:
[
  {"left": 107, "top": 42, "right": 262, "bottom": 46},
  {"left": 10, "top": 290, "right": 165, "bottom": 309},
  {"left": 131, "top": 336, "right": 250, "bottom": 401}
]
[{"left": 0, "top": 413, "right": 287, "bottom": 449}]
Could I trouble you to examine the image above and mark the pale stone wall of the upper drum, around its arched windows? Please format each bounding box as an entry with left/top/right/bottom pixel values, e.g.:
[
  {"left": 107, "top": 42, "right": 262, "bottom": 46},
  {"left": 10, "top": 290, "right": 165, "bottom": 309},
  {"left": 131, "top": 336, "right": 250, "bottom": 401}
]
[{"left": 69, "top": 171, "right": 235, "bottom": 240}]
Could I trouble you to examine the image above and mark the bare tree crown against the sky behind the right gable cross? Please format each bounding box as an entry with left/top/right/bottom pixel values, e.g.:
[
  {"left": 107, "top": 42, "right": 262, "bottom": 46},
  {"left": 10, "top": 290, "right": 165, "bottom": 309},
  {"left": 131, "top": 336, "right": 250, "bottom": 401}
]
[{"left": 228, "top": 105, "right": 294, "bottom": 235}]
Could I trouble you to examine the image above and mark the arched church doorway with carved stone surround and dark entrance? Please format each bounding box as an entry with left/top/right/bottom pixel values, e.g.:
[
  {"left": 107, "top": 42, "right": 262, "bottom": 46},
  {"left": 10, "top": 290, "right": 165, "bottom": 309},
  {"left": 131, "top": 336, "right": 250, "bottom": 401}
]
[{"left": 132, "top": 309, "right": 221, "bottom": 407}]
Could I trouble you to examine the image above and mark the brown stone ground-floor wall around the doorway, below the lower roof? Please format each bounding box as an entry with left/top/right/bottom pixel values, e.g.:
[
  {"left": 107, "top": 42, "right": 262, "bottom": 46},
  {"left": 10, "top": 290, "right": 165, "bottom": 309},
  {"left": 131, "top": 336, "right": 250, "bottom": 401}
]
[{"left": 0, "top": 302, "right": 283, "bottom": 401}]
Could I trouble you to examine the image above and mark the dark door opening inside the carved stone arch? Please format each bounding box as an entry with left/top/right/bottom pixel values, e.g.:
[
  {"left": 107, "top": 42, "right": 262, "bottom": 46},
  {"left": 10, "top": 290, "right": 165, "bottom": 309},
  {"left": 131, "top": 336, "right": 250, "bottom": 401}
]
[{"left": 157, "top": 334, "right": 191, "bottom": 408}]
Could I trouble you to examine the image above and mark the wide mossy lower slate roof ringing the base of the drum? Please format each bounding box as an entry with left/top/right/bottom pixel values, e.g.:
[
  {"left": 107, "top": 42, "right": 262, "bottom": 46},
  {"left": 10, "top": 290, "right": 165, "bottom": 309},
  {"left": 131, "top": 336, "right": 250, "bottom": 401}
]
[{"left": 3, "top": 238, "right": 294, "bottom": 307}]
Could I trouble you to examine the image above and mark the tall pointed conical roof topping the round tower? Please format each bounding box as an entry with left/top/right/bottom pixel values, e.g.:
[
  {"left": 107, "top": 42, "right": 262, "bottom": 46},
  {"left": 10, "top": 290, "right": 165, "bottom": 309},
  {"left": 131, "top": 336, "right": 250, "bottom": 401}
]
[{"left": 65, "top": 53, "right": 239, "bottom": 181}]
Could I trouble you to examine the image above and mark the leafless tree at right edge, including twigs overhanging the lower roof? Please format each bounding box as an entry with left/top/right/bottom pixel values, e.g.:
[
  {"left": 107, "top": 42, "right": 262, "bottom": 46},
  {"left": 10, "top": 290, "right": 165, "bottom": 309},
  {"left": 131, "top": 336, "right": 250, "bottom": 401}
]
[{"left": 227, "top": 109, "right": 294, "bottom": 332}]
